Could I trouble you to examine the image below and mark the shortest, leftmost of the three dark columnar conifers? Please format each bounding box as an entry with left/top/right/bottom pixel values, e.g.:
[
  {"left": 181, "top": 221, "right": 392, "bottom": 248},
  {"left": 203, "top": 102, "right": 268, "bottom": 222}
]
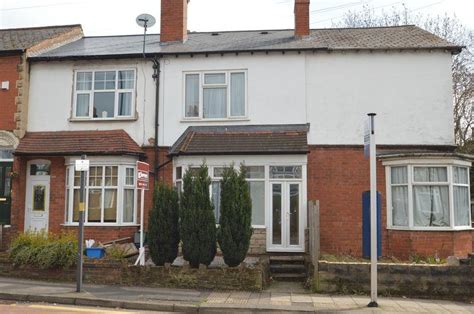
[{"left": 148, "top": 182, "right": 179, "bottom": 266}]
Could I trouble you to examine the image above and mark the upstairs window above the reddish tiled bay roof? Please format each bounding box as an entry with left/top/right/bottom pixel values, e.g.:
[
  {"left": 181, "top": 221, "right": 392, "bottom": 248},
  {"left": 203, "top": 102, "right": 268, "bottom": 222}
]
[{"left": 73, "top": 70, "right": 135, "bottom": 119}]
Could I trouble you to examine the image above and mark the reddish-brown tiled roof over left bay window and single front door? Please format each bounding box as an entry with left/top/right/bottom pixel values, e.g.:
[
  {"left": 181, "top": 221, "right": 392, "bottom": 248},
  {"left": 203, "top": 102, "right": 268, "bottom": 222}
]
[{"left": 15, "top": 130, "right": 144, "bottom": 156}]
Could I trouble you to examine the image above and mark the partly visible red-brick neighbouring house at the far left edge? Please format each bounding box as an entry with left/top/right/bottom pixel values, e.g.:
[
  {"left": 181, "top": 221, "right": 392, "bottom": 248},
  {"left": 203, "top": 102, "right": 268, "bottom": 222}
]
[{"left": 0, "top": 25, "right": 83, "bottom": 234}]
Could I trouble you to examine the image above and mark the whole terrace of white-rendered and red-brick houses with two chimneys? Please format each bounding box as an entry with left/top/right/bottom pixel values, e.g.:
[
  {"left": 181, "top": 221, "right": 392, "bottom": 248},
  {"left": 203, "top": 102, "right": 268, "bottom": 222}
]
[{"left": 7, "top": 0, "right": 474, "bottom": 258}]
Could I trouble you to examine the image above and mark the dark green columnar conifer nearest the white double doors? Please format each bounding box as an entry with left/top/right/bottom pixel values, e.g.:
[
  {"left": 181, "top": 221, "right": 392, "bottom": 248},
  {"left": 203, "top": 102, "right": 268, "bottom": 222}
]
[{"left": 218, "top": 165, "right": 252, "bottom": 267}]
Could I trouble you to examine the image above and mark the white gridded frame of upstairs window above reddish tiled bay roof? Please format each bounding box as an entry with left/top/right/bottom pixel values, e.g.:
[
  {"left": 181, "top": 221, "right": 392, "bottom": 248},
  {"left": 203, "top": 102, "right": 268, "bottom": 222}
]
[{"left": 71, "top": 67, "right": 137, "bottom": 121}]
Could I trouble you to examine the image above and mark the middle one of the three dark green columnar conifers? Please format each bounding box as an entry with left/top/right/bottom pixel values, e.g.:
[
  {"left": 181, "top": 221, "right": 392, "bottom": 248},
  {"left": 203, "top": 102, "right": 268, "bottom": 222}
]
[{"left": 180, "top": 164, "right": 216, "bottom": 267}]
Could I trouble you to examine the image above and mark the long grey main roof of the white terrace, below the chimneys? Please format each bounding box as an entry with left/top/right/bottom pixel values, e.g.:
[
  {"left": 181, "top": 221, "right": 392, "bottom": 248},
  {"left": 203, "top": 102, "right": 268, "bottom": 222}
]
[{"left": 33, "top": 25, "right": 462, "bottom": 60}]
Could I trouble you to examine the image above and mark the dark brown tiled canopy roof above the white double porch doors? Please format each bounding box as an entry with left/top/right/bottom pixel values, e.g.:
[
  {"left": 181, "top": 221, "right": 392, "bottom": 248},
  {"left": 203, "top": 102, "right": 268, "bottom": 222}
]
[{"left": 169, "top": 124, "right": 309, "bottom": 156}]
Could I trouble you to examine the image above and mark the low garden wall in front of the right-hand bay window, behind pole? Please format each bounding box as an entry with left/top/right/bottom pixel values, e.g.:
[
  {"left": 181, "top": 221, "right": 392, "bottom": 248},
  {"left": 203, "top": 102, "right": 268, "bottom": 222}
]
[{"left": 314, "top": 261, "right": 474, "bottom": 301}]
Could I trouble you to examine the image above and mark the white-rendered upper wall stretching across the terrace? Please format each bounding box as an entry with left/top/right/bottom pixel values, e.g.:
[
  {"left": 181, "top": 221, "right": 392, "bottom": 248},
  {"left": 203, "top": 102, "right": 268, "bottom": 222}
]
[{"left": 28, "top": 52, "right": 454, "bottom": 146}]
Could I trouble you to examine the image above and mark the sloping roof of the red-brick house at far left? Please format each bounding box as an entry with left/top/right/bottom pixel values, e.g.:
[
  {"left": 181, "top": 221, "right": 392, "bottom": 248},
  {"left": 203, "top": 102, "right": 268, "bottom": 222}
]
[{"left": 0, "top": 24, "right": 81, "bottom": 52}]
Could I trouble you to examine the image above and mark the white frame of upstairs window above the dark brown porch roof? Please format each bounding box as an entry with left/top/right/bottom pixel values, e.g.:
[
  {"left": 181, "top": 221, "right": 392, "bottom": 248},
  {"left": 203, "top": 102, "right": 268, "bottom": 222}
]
[{"left": 182, "top": 69, "right": 248, "bottom": 121}]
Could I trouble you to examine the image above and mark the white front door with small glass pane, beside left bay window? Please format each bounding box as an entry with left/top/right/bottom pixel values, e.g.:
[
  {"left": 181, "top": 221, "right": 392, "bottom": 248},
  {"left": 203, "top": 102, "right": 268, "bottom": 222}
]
[{"left": 25, "top": 176, "right": 50, "bottom": 231}]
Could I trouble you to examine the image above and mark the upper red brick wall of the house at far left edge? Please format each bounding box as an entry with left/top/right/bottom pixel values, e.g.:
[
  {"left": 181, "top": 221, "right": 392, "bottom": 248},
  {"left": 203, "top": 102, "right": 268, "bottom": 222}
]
[{"left": 0, "top": 55, "right": 21, "bottom": 131}]
